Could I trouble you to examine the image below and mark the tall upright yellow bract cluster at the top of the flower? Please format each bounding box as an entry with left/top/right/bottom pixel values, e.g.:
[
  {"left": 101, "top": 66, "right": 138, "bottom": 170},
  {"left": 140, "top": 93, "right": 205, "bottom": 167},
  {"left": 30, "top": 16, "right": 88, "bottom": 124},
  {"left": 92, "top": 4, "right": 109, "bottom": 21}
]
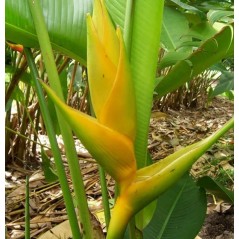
[{"left": 87, "top": 1, "right": 136, "bottom": 140}]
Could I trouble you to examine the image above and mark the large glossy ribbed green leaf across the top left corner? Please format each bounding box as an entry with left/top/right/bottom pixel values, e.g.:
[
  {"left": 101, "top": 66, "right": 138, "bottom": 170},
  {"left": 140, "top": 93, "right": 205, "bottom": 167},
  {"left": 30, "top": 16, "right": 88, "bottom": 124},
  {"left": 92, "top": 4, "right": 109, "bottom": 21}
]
[{"left": 5, "top": 0, "right": 92, "bottom": 64}]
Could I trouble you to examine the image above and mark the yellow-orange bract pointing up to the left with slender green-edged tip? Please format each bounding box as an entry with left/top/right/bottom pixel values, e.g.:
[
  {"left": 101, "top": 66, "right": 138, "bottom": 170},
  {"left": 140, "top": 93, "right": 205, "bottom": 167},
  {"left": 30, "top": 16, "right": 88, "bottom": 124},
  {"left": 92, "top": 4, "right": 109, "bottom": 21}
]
[{"left": 42, "top": 83, "right": 136, "bottom": 190}]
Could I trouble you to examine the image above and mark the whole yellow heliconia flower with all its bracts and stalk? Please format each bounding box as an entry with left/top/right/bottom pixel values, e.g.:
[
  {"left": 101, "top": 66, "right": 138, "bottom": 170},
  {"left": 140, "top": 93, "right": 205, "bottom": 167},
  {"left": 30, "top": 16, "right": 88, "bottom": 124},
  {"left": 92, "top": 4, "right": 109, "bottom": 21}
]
[{"left": 42, "top": 0, "right": 233, "bottom": 239}]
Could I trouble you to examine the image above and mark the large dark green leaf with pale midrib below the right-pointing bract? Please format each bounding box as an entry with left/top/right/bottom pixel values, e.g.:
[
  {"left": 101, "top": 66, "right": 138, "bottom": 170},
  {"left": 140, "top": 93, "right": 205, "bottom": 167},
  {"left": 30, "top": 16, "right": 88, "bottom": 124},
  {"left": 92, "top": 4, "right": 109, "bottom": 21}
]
[{"left": 144, "top": 173, "right": 207, "bottom": 239}]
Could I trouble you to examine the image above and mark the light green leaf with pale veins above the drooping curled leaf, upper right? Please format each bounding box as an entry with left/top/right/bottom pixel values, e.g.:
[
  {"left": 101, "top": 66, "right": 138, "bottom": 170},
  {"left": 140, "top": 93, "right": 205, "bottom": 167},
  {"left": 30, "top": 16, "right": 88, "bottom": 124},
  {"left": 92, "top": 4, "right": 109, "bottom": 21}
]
[{"left": 158, "top": 18, "right": 221, "bottom": 70}]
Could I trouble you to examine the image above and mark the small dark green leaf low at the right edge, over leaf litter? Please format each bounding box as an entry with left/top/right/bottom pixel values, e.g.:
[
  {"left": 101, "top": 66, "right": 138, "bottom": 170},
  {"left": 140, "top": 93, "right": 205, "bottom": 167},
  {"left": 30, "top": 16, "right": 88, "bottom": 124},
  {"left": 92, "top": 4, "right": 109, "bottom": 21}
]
[{"left": 198, "top": 176, "right": 234, "bottom": 203}]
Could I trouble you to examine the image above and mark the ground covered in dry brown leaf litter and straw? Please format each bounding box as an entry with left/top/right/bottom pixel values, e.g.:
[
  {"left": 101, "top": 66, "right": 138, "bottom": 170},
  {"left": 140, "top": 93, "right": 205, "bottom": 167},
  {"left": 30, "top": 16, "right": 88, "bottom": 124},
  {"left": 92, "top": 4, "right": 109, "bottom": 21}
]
[{"left": 5, "top": 98, "right": 234, "bottom": 239}]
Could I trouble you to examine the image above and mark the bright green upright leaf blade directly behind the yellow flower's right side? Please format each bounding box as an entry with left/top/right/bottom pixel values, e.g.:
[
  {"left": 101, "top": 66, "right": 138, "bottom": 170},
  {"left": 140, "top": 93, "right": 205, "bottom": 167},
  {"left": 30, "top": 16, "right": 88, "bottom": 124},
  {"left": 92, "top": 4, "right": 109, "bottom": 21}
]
[{"left": 130, "top": 0, "right": 164, "bottom": 168}]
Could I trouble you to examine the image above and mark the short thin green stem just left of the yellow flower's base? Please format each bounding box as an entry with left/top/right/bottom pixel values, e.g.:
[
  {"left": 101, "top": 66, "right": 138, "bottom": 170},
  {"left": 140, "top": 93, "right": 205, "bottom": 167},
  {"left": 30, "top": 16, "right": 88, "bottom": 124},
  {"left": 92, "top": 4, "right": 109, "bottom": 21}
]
[{"left": 99, "top": 166, "right": 110, "bottom": 229}]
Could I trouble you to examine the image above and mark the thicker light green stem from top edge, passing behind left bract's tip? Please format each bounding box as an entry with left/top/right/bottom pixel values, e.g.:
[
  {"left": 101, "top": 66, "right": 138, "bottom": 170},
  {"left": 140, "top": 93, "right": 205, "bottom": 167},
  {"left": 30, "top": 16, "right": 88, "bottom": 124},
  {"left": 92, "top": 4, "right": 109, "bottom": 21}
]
[{"left": 28, "top": 0, "right": 93, "bottom": 239}]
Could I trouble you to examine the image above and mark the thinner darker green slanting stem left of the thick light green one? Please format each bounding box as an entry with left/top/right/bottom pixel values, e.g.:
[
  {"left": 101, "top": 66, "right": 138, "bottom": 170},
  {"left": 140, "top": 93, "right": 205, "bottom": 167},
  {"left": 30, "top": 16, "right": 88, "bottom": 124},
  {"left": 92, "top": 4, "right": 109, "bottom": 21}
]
[{"left": 25, "top": 48, "right": 81, "bottom": 238}]
